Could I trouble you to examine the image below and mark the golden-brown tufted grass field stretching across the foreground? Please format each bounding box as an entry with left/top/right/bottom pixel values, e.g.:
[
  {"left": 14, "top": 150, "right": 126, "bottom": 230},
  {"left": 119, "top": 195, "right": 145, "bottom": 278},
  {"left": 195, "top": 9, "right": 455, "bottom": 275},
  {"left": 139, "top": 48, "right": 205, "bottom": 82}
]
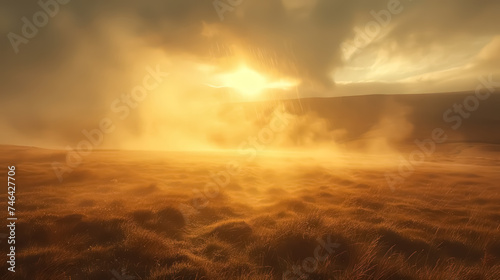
[{"left": 0, "top": 143, "right": 500, "bottom": 280}]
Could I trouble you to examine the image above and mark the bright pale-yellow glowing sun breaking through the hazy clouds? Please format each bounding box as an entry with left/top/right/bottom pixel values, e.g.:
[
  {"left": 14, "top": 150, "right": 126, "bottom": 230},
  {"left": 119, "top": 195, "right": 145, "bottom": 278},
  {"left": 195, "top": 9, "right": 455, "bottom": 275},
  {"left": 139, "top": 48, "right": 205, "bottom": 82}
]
[{"left": 209, "top": 66, "right": 295, "bottom": 96}]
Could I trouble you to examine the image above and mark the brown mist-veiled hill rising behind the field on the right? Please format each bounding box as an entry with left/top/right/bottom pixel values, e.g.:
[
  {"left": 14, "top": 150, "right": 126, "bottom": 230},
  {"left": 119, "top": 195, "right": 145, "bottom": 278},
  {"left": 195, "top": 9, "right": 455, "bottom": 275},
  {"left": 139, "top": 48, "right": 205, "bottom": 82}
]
[{"left": 234, "top": 90, "right": 500, "bottom": 147}]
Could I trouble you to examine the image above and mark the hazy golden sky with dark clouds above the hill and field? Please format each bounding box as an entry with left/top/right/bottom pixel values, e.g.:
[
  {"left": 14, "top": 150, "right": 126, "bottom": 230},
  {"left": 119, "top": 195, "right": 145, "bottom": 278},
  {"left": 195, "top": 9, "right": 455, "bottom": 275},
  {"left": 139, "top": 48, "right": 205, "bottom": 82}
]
[{"left": 0, "top": 0, "right": 500, "bottom": 149}]
